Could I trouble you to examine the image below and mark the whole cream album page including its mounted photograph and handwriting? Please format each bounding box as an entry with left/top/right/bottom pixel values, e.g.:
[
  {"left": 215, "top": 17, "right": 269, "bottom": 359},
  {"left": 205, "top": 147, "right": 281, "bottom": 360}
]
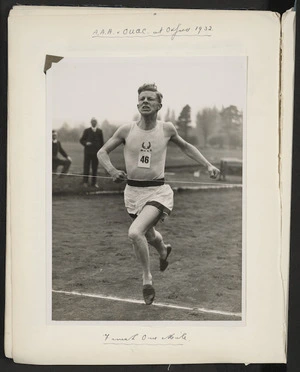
[{"left": 5, "top": 6, "right": 295, "bottom": 365}]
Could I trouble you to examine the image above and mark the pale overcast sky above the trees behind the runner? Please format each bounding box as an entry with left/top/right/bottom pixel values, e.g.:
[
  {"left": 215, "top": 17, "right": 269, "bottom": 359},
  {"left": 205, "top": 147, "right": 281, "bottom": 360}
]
[{"left": 47, "top": 57, "right": 247, "bottom": 128}]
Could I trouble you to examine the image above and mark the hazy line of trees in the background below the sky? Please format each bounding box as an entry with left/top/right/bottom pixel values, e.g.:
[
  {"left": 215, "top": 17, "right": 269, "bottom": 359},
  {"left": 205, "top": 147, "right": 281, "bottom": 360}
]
[{"left": 58, "top": 105, "right": 243, "bottom": 148}]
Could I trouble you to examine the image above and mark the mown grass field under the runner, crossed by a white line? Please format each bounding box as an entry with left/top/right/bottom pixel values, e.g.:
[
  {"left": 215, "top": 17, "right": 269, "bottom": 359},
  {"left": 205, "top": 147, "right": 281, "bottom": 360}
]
[{"left": 52, "top": 190, "right": 242, "bottom": 321}]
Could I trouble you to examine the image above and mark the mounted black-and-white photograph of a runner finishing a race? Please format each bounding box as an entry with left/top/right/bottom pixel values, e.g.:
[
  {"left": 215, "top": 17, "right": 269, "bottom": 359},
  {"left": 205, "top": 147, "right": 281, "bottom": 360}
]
[{"left": 46, "top": 55, "right": 247, "bottom": 325}]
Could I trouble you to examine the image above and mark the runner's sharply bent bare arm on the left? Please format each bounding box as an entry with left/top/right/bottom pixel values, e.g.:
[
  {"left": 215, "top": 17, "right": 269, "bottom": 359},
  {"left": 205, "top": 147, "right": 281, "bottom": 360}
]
[{"left": 97, "top": 124, "right": 130, "bottom": 183}]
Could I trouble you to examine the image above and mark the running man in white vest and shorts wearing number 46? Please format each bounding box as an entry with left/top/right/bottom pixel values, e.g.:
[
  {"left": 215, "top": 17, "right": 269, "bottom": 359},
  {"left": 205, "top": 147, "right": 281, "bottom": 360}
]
[{"left": 98, "top": 84, "right": 219, "bottom": 305}]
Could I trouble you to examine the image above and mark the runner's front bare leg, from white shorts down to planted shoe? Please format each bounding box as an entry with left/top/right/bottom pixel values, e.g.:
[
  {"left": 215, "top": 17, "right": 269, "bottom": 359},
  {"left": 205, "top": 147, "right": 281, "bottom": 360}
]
[{"left": 128, "top": 205, "right": 160, "bottom": 285}]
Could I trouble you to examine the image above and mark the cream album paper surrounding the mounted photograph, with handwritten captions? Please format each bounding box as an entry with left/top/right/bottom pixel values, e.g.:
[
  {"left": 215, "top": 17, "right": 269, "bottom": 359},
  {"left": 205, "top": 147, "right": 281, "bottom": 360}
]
[{"left": 6, "top": 7, "right": 290, "bottom": 364}]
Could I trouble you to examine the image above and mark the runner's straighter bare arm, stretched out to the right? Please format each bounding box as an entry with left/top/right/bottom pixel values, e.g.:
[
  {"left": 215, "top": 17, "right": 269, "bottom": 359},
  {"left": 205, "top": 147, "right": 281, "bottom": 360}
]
[{"left": 164, "top": 122, "right": 220, "bottom": 179}]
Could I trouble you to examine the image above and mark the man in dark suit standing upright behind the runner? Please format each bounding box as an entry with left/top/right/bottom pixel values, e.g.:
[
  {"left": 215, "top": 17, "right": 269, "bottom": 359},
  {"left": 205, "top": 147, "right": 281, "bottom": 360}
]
[{"left": 80, "top": 118, "right": 104, "bottom": 188}]
